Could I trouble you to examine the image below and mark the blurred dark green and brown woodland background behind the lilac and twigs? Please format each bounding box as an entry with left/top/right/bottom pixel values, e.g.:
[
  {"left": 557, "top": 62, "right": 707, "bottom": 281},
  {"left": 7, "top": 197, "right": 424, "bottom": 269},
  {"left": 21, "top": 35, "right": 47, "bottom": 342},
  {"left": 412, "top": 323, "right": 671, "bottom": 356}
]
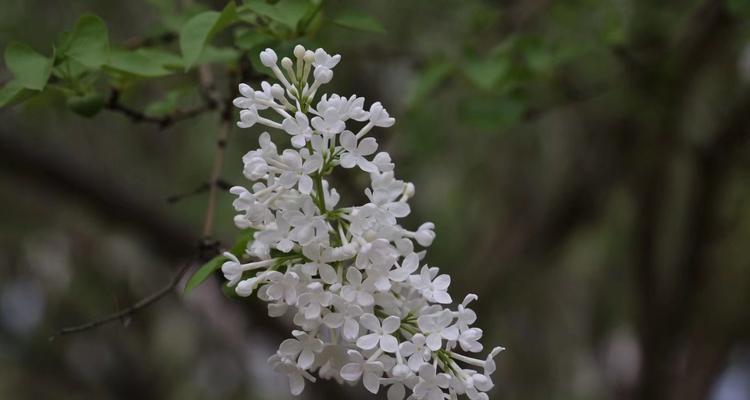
[{"left": 0, "top": 0, "right": 750, "bottom": 400}]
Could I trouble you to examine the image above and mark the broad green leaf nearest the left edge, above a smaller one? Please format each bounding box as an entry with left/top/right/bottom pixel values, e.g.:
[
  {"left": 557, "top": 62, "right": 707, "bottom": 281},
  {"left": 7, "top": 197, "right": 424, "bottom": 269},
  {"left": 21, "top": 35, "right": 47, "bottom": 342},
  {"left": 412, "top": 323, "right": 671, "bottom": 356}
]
[{"left": 5, "top": 42, "right": 54, "bottom": 90}]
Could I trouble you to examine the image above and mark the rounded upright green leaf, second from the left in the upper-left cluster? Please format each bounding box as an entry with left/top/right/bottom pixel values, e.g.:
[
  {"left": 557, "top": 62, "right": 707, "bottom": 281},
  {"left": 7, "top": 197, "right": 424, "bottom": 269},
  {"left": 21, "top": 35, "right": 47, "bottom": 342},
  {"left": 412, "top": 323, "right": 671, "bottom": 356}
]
[{"left": 66, "top": 14, "right": 109, "bottom": 68}]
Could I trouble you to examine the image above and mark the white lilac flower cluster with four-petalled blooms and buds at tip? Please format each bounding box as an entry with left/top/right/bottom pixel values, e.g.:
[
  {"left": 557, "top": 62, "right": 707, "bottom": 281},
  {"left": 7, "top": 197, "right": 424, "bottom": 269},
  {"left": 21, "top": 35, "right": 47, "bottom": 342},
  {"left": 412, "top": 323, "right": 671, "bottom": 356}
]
[{"left": 222, "top": 46, "right": 503, "bottom": 400}]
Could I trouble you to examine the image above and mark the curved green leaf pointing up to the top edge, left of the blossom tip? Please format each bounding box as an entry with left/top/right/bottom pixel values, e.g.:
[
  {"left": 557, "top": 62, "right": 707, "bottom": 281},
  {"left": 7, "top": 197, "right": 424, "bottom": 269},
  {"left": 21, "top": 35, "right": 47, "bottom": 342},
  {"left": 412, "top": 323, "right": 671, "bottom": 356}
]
[{"left": 180, "top": 1, "right": 237, "bottom": 70}]
